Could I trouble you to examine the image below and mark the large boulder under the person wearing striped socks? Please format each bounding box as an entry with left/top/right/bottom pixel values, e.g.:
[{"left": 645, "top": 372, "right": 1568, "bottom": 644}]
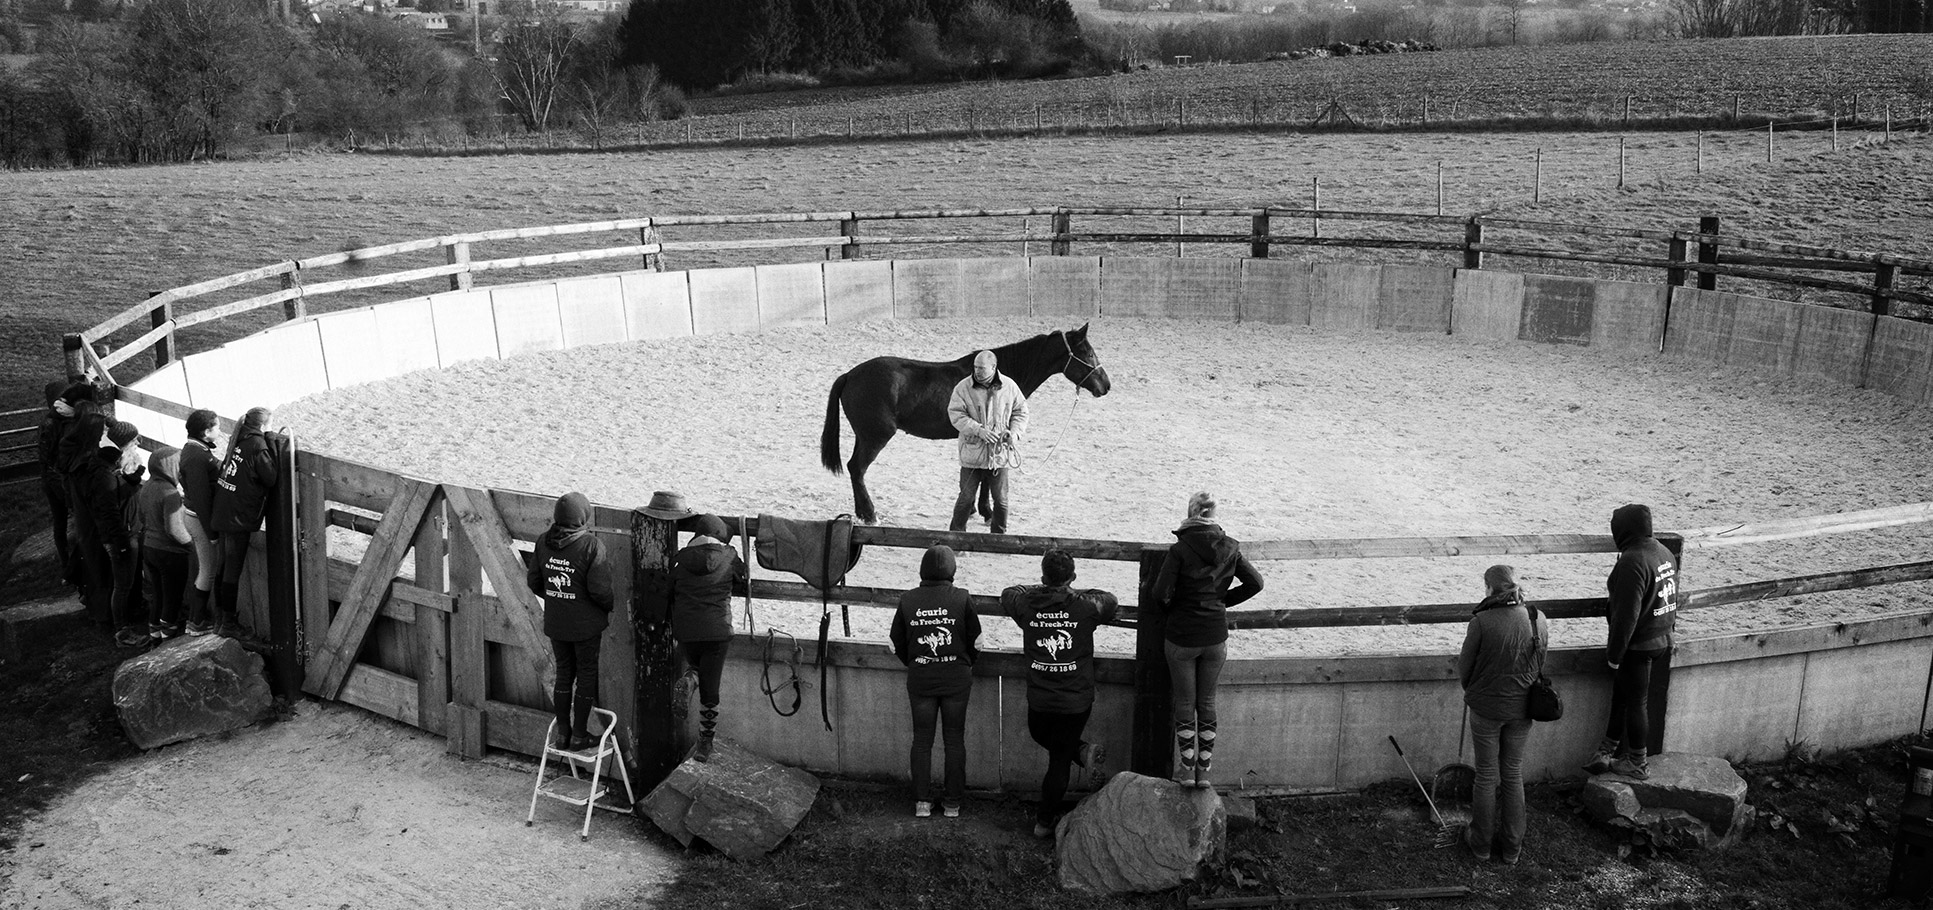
[{"left": 1055, "top": 773, "right": 1227, "bottom": 895}]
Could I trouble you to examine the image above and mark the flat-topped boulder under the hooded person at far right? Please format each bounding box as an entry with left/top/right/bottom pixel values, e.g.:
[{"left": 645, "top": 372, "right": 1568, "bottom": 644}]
[{"left": 1579, "top": 752, "right": 1751, "bottom": 848}]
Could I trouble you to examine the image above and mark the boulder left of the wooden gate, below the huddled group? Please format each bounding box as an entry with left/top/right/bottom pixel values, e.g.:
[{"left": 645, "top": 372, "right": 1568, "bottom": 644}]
[{"left": 114, "top": 636, "right": 273, "bottom": 750}]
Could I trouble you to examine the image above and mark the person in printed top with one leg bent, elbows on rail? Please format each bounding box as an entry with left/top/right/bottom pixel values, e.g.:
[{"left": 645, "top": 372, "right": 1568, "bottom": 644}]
[{"left": 999, "top": 549, "right": 1121, "bottom": 837}]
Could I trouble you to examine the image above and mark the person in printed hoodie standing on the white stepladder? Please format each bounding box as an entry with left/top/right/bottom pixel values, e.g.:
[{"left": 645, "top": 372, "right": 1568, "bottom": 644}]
[{"left": 524, "top": 493, "right": 615, "bottom": 752}]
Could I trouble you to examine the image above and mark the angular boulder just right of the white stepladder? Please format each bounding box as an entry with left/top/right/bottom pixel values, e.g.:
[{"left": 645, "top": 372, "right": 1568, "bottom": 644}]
[{"left": 640, "top": 738, "right": 820, "bottom": 862}]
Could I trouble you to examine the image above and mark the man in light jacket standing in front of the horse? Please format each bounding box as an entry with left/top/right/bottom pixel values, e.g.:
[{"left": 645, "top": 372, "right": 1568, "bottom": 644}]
[{"left": 947, "top": 352, "right": 1026, "bottom": 533}]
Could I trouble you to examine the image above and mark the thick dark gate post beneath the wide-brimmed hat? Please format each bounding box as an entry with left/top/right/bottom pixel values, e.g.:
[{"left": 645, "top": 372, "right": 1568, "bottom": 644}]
[{"left": 630, "top": 508, "right": 688, "bottom": 792}]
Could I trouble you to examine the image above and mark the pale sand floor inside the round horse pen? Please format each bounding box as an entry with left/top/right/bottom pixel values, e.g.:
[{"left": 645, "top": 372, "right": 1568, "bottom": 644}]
[{"left": 276, "top": 319, "right": 1933, "bottom": 657}]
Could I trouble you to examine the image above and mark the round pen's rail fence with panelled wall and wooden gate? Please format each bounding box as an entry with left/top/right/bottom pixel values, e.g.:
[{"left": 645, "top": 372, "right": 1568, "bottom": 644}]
[{"left": 56, "top": 207, "right": 1933, "bottom": 790}]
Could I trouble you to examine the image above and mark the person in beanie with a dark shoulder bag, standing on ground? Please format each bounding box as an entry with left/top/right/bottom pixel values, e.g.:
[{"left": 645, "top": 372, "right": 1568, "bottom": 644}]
[{"left": 1456, "top": 566, "right": 1550, "bottom": 864}]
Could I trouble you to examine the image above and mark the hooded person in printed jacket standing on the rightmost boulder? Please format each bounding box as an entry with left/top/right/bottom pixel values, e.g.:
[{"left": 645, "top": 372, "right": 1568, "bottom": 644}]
[{"left": 1585, "top": 502, "right": 1678, "bottom": 781}]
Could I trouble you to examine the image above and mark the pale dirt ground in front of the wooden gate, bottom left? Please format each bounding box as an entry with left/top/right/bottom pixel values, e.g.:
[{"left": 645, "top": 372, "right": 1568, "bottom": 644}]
[{"left": 0, "top": 701, "right": 677, "bottom": 910}]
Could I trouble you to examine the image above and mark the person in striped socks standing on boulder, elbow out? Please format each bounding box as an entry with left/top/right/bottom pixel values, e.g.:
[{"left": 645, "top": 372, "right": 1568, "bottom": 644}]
[{"left": 1152, "top": 493, "right": 1262, "bottom": 788}]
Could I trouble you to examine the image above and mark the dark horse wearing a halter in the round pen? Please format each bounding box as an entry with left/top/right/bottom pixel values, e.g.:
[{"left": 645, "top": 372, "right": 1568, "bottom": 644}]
[{"left": 820, "top": 325, "right": 1110, "bottom": 524}]
